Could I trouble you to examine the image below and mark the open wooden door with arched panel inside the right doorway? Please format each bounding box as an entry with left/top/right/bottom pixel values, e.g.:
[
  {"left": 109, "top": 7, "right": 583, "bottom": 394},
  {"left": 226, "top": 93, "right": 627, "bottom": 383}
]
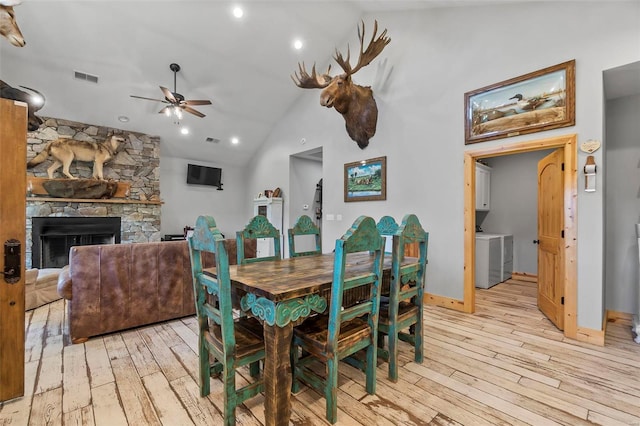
[{"left": 538, "top": 148, "right": 564, "bottom": 330}]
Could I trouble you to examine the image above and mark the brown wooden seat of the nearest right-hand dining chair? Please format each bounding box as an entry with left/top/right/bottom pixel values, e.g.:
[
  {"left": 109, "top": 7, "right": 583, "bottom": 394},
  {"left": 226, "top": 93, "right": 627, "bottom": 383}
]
[{"left": 293, "top": 315, "right": 371, "bottom": 357}]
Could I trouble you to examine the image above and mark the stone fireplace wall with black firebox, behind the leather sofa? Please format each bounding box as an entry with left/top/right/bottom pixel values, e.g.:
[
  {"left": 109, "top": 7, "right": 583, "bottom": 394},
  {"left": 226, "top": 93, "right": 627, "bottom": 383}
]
[{"left": 25, "top": 118, "right": 162, "bottom": 268}]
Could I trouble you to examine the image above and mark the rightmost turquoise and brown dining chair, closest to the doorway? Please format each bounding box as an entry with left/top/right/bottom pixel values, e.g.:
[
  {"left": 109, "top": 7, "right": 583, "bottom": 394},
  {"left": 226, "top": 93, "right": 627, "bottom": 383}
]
[{"left": 378, "top": 214, "right": 429, "bottom": 382}]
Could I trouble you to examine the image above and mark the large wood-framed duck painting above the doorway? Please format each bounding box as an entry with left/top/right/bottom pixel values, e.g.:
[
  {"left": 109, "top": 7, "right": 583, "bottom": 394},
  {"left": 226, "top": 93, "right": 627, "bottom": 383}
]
[{"left": 464, "top": 60, "right": 576, "bottom": 145}]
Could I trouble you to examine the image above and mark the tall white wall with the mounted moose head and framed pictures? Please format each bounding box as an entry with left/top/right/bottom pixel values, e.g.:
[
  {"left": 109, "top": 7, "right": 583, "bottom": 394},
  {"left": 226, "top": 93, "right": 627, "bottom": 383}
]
[{"left": 247, "top": 2, "right": 640, "bottom": 330}]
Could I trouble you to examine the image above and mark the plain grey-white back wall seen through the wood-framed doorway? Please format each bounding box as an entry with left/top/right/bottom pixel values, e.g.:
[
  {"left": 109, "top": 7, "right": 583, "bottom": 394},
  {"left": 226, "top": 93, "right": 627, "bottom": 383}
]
[{"left": 482, "top": 150, "right": 550, "bottom": 275}]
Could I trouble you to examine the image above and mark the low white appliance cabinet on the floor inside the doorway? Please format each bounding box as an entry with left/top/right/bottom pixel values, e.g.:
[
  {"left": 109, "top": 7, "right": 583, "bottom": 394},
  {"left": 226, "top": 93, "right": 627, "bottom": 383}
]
[{"left": 476, "top": 232, "right": 513, "bottom": 288}]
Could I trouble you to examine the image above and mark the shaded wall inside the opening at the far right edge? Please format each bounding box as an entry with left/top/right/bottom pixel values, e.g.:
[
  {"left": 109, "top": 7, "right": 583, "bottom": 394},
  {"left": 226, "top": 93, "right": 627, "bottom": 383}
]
[{"left": 597, "top": 95, "right": 640, "bottom": 314}]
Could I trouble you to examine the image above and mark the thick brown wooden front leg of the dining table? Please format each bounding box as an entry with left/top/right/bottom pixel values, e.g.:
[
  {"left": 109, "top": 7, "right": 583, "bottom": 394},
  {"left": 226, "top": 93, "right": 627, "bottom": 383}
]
[{"left": 264, "top": 323, "right": 293, "bottom": 426}]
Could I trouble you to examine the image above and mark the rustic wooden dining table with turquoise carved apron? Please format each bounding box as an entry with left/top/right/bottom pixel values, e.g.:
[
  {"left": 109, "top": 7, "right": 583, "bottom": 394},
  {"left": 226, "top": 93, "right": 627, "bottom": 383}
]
[{"left": 203, "top": 252, "right": 410, "bottom": 426}]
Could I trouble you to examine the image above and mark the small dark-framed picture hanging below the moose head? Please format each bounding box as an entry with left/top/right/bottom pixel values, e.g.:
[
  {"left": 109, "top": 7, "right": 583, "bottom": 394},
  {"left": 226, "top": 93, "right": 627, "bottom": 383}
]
[{"left": 344, "top": 157, "right": 387, "bottom": 202}]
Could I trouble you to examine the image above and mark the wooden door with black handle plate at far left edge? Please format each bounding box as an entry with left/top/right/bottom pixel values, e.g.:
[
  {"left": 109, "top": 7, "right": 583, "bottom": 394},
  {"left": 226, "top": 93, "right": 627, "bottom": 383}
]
[{"left": 0, "top": 99, "right": 27, "bottom": 401}]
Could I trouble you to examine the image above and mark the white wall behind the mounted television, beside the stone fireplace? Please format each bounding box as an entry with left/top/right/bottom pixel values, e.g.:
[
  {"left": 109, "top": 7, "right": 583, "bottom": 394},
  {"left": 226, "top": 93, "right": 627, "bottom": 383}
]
[{"left": 160, "top": 157, "right": 248, "bottom": 238}]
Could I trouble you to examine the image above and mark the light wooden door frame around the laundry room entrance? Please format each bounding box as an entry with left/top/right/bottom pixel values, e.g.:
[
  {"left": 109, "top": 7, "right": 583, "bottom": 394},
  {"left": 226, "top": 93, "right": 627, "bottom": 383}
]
[{"left": 464, "top": 134, "right": 578, "bottom": 339}]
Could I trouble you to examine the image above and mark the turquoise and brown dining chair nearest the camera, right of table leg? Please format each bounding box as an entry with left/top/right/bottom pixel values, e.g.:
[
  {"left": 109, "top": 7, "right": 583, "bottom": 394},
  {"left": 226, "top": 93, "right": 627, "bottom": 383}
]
[{"left": 291, "top": 216, "right": 384, "bottom": 424}]
